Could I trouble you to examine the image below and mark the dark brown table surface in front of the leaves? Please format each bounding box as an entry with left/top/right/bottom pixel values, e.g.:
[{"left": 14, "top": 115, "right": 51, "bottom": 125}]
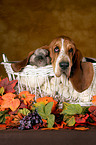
[{"left": 0, "top": 126, "right": 96, "bottom": 145}]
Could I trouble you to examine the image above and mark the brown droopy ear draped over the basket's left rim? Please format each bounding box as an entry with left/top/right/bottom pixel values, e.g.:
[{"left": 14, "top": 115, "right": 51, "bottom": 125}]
[{"left": 11, "top": 51, "right": 34, "bottom": 72}]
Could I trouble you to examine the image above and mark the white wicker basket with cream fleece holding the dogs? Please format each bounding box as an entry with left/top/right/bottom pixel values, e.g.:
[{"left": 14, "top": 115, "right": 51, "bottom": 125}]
[{"left": 1, "top": 54, "right": 96, "bottom": 106}]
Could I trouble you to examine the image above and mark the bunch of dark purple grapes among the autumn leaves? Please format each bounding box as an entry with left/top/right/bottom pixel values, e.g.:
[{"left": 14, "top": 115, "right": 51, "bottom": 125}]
[{"left": 18, "top": 110, "right": 43, "bottom": 130}]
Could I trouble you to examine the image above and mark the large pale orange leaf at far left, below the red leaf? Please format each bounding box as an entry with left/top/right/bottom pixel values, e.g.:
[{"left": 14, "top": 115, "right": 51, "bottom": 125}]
[{"left": 1, "top": 93, "right": 20, "bottom": 111}]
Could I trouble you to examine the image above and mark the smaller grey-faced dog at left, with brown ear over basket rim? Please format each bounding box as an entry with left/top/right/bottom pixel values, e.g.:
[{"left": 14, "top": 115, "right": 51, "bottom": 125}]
[{"left": 10, "top": 45, "right": 51, "bottom": 72}]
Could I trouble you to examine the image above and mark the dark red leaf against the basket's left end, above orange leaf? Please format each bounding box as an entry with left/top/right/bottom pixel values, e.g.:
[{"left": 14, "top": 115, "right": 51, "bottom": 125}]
[{"left": 0, "top": 77, "right": 18, "bottom": 93}]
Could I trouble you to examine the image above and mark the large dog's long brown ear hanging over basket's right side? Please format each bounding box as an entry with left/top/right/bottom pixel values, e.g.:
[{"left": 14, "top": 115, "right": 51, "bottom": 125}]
[{"left": 70, "top": 50, "right": 94, "bottom": 92}]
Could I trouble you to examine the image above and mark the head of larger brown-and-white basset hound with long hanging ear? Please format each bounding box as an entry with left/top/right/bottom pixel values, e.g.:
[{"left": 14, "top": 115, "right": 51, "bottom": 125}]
[{"left": 49, "top": 36, "right": 94, "bottom": 92}]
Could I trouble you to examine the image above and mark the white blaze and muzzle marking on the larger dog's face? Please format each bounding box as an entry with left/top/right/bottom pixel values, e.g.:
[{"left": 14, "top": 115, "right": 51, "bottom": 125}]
[{"left": 55, "top": 39, "right": 70, "bottom": 75}]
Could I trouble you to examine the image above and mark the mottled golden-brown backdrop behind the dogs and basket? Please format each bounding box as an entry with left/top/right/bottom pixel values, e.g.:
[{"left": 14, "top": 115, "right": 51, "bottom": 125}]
[{"left": 0, "top": 0, "right": 96, "bottom": 76}]
